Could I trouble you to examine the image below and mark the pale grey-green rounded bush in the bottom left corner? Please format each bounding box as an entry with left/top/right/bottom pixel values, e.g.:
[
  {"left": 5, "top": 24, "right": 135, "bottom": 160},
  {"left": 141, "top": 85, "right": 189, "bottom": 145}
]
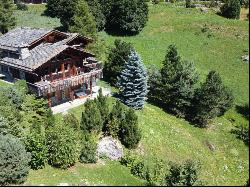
[{"left": 0, "top": 135, "right": 30, "bottom": 185}]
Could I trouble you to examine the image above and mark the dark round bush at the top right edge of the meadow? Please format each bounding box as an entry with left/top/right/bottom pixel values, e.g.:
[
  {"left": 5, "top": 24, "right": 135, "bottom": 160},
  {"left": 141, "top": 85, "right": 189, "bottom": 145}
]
[{"left": 220, "top": 0, "right": 241, "bottom": 19}]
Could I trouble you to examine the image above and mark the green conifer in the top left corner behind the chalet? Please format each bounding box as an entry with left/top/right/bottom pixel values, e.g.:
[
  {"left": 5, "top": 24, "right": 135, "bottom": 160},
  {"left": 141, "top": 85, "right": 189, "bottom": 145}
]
[{"left": 0, "top": 0, "right": 16, "bottom": 34}]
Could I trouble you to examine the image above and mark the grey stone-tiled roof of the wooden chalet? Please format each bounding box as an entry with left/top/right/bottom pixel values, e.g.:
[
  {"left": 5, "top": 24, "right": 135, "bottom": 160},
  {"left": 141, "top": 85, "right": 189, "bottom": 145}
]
[{"left": 0, "top": 27, "right": 94, "bottom": 71}]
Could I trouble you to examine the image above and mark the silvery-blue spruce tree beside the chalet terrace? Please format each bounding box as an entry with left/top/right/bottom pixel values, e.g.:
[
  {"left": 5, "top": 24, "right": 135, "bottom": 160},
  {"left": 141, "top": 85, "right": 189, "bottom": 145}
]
[{"left": 118, "top": 50, "right": 148, "bottom": 109}]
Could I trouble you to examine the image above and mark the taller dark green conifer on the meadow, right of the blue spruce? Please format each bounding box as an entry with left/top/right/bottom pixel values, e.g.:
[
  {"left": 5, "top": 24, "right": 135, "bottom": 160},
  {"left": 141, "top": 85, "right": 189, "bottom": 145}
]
[{"left": 160, "top": 45, "right": 199, "bottom": 117}]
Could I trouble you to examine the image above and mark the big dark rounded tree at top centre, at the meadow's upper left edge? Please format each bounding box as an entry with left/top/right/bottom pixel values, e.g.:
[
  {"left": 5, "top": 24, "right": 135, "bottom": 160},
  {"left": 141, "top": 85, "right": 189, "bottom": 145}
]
[{"left": 106, "top": 0, "right": 148, "bottom": 34}]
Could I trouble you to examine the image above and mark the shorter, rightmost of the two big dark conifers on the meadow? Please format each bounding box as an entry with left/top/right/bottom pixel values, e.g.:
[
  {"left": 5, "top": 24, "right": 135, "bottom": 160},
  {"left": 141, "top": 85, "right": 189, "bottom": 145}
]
[{"left": 194, "top": 71, "right": 234, "bottom": 127}]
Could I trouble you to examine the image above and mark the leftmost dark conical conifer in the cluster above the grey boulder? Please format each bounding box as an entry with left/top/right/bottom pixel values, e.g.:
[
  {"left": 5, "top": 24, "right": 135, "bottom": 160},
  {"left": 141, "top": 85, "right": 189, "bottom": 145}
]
[{"left": 81, "top": 100, "right": 103, "bottom": 133}]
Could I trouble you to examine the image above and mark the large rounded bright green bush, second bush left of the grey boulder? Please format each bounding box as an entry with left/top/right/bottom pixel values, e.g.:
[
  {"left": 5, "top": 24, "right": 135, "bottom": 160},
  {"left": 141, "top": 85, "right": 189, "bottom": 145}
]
[{"left": 46, "top": 124, "right": 79, "bottom": 168}]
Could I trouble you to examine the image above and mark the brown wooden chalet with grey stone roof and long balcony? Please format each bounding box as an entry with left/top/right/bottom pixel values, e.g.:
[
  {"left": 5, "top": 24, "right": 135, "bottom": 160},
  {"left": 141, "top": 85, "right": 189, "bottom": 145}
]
[{"left": 0, "top": 27, "right": 102, "bottom": 106}]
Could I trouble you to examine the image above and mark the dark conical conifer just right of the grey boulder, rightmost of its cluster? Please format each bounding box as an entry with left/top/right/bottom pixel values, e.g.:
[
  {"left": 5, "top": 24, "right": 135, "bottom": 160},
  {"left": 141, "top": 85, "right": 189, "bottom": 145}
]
[{"left": 119, "top": 109, "right": 141, "bottom": 149}]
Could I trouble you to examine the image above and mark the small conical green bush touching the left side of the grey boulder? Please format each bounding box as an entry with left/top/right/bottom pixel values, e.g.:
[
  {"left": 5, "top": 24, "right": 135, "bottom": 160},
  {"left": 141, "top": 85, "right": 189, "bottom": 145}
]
[{"left": 79, "top": 134, "right": 97, "bottom": 163}]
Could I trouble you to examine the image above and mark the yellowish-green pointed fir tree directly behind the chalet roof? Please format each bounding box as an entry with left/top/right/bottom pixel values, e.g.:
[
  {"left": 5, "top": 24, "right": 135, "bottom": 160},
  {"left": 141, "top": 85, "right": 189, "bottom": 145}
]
[{"left": 69, "top": 0, "right": 96, "bottom": 37}]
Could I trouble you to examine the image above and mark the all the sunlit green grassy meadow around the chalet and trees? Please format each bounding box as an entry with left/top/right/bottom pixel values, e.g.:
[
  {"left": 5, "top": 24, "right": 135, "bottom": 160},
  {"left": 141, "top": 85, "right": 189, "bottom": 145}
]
[{"left": 9, "top": 4, "right": 249, "bottom": 185}]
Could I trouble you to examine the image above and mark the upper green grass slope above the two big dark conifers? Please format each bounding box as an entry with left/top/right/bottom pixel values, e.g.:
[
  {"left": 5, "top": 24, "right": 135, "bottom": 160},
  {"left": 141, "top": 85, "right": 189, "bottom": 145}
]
[{"left": 101, "top": 4, "right": 249, "bottom": 104}]
